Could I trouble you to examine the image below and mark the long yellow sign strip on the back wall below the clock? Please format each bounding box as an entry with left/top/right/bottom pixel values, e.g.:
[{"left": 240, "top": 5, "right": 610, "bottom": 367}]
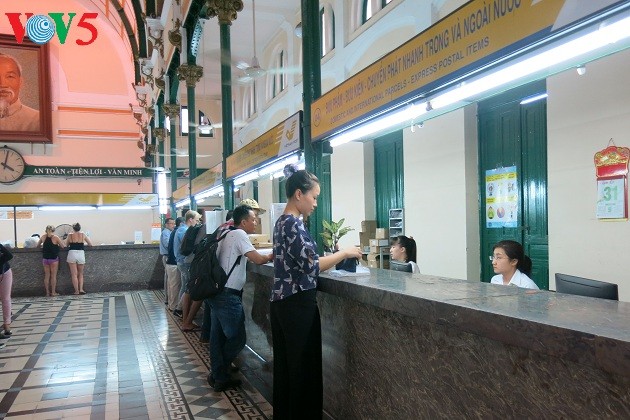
[{"left": 0, "top": 193, "right": 158, "bottom": 206}]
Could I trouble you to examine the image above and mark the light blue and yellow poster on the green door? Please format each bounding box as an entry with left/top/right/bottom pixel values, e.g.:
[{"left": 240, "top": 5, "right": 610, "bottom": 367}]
[{"left": 486, "top": 166, "right": 519, "bottom": 228}]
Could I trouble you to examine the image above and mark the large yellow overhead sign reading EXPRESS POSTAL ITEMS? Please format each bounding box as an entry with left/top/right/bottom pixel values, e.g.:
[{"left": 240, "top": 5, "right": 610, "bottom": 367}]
[{"left": 311, "top": 0, "right": 568, "bottom": 141}]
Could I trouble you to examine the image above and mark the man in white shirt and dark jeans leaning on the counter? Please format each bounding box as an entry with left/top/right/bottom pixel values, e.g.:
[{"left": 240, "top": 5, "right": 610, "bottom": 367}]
[{"left": 208, "top": 205, "right": 273, "bottom": 392}]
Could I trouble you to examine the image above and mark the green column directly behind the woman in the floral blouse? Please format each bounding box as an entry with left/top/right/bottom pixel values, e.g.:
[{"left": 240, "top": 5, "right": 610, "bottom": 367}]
[{"left": 302, "top": 0, "right": 332, "bottom": 253}]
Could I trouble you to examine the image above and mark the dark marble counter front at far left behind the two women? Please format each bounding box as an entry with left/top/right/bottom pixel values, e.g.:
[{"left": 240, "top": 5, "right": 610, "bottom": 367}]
[{"left": 10, "top": 244, "right": 164, "bottom": 297}]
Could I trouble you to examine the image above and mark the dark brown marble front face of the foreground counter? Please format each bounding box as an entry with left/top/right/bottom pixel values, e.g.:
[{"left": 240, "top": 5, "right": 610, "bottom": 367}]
[{"left": 319, "top": 293, "right": 630, "bottom": 419}]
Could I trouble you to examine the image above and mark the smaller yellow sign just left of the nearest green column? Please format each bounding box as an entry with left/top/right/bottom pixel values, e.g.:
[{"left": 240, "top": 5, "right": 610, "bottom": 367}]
[{"left": 225, "top": 111, "right": 302, "bottom": 178}]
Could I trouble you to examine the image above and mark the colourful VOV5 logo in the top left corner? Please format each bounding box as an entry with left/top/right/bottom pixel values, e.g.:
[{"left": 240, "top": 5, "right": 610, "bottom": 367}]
[{"left": 5, "top": 12, "right": 98, "bottom": 45}]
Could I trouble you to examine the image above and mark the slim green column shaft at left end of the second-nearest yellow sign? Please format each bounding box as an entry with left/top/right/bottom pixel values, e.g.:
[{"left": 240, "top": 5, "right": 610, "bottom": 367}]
[{"left": 219, "top": 23, "right": 234, "bottom": 210}]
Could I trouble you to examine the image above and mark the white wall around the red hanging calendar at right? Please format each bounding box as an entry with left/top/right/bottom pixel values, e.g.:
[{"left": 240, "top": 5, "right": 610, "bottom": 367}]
[{"left": 547, "top": 51, "right": 630, "bottom": 301}]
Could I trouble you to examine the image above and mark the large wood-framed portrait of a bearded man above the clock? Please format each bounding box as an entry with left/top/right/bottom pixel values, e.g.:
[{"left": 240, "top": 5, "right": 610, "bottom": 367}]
[{"left": 0, "top": 35, "right": 52, "bottom": 143}]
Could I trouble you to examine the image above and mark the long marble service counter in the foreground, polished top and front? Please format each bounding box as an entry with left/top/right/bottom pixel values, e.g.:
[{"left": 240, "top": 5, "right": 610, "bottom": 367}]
[{"left": 244, "top": 265, "right": 630, "bottom": 419}]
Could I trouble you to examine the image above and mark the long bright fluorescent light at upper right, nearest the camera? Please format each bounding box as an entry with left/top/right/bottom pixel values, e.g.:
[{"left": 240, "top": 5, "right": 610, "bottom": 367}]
[{"left": 432, "top": 17, "right": 630, "bottom": 109}]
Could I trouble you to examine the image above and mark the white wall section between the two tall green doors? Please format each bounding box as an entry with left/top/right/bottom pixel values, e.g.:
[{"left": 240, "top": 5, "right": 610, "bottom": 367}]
[{"left": 403, "top": 109, "right": 479, "bottom": 279}]
